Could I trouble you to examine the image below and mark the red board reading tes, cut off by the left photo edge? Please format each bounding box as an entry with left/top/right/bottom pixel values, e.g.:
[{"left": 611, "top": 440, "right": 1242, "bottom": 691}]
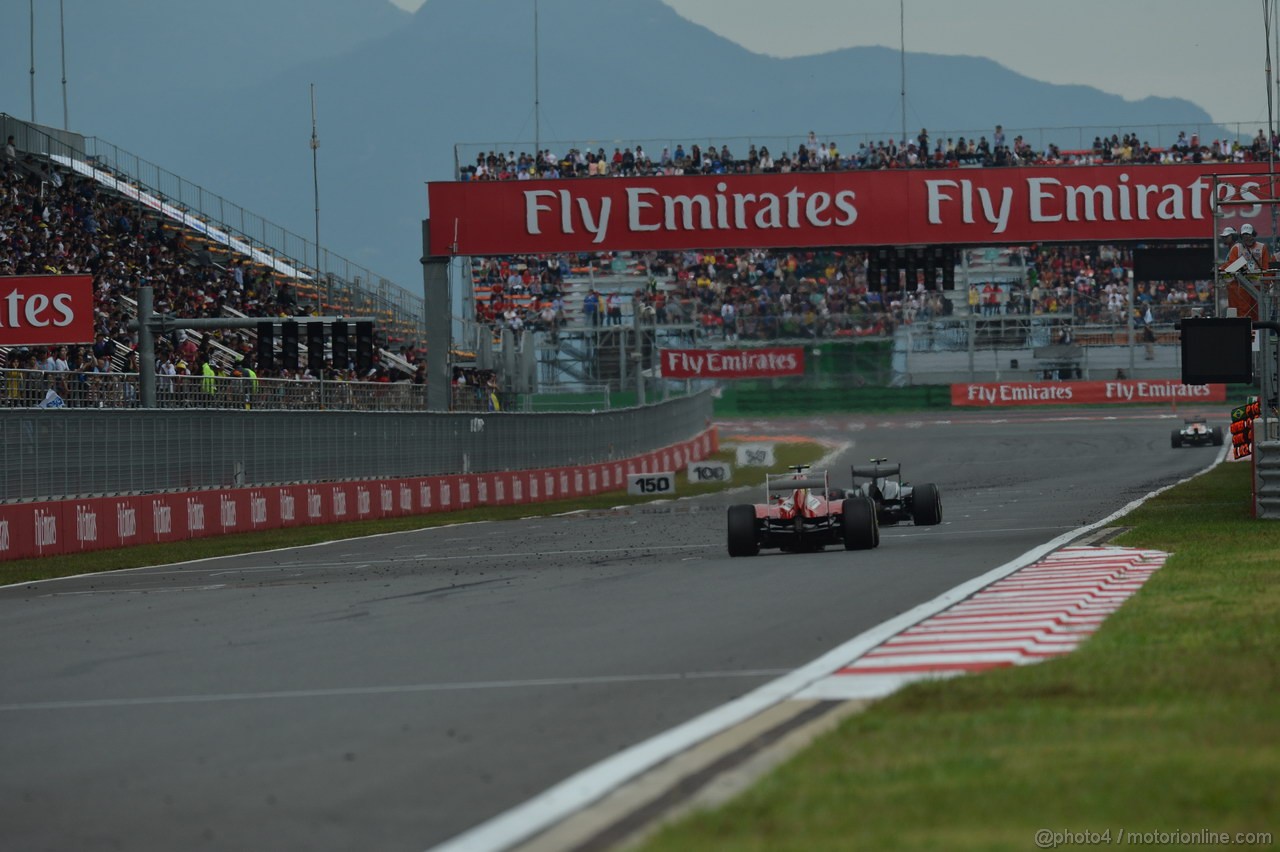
[{"left": 0, "top": 275, "right": 93, "bottom": 347}]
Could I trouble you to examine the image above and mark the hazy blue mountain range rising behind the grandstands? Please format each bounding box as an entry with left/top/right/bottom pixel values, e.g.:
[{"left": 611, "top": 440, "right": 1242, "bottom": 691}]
[{"left": 0, "top": 0, "right": 1211, "bottom": 292}]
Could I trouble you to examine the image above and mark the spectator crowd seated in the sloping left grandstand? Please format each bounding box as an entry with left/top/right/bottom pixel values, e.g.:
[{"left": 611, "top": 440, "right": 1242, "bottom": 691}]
[{"left": 0, "top": 139, "right": 425, "bottom": 406}]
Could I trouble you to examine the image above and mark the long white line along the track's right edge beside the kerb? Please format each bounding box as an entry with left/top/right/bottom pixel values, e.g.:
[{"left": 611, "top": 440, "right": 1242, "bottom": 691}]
[{"left": 431, "top": 446, "right": 1228, "bottom": 852}]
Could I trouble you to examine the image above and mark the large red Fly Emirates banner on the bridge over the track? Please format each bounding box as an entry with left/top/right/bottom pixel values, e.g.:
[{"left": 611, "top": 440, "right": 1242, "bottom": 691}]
[{"left": 428, "top": 164, "right": 1271, "bottom": 257}]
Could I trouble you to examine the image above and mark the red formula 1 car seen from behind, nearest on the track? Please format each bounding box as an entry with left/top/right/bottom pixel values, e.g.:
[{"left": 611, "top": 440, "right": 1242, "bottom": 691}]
[{"left": 728, "top": 464, "right": 879, "bottom": 556}]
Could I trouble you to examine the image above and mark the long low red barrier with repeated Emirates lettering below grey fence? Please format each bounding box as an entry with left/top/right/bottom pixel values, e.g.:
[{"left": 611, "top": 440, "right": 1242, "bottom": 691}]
[{"left": 0, "top": 429, "right": 719, "bottom": 560}]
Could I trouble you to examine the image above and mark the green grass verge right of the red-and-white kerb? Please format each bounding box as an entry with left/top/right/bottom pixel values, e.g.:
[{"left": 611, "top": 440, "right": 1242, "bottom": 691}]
[{"left": 643, "top": 464, "right": 1280, "bottom": 852}]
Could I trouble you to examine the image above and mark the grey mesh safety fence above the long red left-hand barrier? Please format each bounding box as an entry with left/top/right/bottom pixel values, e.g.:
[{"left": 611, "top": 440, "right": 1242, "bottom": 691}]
[{"left": 0, "top": 393, "right": 712, "bottom": 503}]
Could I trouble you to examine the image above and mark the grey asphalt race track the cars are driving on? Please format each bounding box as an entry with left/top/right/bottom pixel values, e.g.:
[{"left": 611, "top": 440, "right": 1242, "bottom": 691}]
[{"left": 0, "top": 409, "right": 1220, "bottom": 852}]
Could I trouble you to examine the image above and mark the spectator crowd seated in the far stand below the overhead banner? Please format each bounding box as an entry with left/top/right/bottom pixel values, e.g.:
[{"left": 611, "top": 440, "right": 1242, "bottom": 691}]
[{"left": 475, "top": 244, "right": 1213, "bottom": 342}]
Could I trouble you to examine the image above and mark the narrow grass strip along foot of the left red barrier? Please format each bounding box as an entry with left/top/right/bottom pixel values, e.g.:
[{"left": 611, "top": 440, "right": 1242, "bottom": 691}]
[{"left": 0, "top": 441, "right": 827, "bottom": 586}]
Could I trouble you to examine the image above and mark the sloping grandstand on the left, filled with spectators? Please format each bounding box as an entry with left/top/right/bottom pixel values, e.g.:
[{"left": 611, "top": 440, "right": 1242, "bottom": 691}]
[{"left": 0, "top": 115, "right": 425, "bottom": 408}]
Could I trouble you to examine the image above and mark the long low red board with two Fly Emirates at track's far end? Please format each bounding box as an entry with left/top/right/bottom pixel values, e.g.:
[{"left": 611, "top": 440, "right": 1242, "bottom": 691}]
[{"left": 951, "top": 379, "right": 1226, "bottom": 407}]
